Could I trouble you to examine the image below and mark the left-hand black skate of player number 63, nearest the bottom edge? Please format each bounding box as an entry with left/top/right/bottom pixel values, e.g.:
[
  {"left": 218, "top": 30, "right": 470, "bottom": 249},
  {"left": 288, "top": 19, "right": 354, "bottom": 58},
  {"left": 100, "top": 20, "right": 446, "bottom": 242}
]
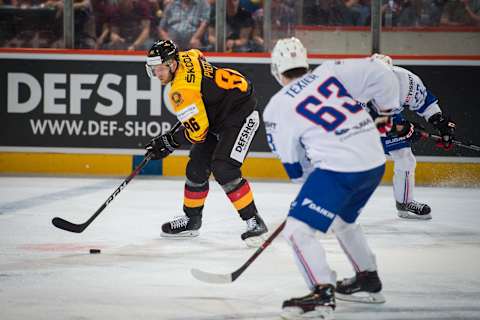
[{"left": 281, "top": 285, "right": 335, "bottom": 320}]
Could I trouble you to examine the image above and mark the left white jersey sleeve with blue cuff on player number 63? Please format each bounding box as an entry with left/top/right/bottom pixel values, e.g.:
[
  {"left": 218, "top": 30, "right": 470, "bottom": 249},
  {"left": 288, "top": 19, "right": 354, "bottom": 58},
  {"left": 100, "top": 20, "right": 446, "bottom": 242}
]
[{"left": 263, "top": 100, "right": 313, "bottom": 182}]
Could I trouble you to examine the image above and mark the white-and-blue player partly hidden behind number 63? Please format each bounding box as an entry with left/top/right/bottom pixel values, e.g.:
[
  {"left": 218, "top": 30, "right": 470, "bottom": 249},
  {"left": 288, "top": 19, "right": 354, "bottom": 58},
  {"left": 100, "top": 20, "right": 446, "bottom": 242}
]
[{"left": 368, "top": 54, "right": 455, "bottom": 220}]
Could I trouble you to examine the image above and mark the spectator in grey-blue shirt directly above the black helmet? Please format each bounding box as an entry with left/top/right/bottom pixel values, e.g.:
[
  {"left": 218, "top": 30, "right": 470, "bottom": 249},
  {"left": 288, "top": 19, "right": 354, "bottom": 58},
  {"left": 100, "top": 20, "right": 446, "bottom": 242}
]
[{"left": 159, "top": 0, "right": 210, "bottom": 51}]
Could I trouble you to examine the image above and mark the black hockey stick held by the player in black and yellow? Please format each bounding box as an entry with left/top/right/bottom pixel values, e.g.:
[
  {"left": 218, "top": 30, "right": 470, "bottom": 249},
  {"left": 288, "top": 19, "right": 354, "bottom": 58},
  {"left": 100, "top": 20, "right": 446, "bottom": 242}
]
[{"left": 52, "top": 122, "right": 182, "bottom": 233}]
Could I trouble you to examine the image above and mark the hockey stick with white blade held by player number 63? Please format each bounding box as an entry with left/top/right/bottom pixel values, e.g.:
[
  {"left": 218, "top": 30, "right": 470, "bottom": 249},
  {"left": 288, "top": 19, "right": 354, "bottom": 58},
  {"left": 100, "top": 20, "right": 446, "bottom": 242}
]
[{"left": 190, "top": 220, "right": 286, "bottom": 283}]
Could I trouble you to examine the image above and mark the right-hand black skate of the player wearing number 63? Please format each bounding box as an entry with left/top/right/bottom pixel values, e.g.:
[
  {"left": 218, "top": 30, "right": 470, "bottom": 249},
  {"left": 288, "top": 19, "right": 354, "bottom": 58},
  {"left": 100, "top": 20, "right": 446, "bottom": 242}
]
[{"left": 335, "top": 271, "right": 385, "bottom": 303}]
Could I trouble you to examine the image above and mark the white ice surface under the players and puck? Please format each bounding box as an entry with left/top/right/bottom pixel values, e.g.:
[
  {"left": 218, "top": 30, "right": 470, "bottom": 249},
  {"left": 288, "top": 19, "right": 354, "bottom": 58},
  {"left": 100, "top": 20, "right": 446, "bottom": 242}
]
[{"left": 0, "top": 176, "right": 480, "bottom": 320}]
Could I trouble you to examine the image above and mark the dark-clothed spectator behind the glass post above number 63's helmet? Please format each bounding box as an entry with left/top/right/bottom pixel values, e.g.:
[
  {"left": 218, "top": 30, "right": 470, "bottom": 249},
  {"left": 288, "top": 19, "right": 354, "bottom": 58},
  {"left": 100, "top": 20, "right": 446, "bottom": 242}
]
[{"left": 253, "top": 0, "right": 296, "bottom": 47}]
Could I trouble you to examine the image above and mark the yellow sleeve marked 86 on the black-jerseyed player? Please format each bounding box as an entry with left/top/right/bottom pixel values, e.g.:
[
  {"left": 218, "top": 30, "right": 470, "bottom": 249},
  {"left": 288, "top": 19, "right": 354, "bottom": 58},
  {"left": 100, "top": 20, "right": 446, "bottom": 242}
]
[{"left": 169, "top": 89, "right": 209, "bottom": 143}]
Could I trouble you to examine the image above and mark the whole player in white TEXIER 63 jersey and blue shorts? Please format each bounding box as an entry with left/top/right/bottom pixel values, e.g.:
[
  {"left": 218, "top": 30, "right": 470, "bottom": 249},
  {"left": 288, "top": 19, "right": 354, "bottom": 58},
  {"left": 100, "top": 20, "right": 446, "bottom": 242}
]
[{"left": 263, "top": 38, "right": 399, "bottom": 319}]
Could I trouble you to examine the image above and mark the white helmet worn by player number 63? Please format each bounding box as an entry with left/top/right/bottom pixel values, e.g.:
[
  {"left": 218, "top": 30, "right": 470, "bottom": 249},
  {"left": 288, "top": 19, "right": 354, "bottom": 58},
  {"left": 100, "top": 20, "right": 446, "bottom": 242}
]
[{"left": 271, "top": 37, "right": 308, "bottom": 85}]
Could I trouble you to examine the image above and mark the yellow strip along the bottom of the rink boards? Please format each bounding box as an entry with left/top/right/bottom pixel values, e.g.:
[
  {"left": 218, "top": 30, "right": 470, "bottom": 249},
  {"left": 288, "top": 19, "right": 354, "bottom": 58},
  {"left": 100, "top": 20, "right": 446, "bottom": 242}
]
[{"left": 0, "top": 152, "right": 480, "bottom": 187}]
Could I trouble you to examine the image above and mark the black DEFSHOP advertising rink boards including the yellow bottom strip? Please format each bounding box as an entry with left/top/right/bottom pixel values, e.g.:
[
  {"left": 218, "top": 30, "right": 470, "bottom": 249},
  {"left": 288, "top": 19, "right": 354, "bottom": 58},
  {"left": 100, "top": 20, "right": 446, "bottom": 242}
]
[{"left": 0, "top": 49, "right": 480, "bottom": 186}]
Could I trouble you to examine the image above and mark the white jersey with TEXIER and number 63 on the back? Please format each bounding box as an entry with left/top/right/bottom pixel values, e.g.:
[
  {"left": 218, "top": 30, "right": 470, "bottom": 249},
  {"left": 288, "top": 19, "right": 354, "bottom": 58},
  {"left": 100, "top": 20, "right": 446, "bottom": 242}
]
[{"left": 263, "top": 59, "right": 399, "bottom": 179}]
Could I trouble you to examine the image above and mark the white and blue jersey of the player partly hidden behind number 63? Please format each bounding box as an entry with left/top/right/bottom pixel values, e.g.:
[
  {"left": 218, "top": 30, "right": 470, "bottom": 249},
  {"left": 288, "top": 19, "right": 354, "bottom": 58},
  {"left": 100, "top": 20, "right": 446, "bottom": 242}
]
[{"left": 392, "top": 66, "right": 441, "bottom": 120}]
